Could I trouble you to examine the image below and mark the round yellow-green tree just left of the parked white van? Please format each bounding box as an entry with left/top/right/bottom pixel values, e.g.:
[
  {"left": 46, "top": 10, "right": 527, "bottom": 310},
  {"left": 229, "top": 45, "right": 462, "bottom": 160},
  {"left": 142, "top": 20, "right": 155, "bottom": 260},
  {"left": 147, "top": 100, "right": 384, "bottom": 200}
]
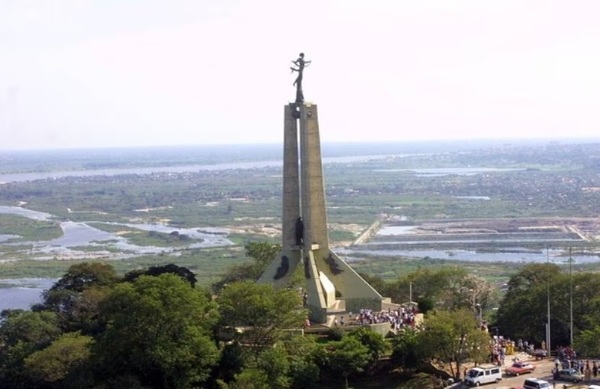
[{"left": 417, "top": 309, "right": 490, "bottom": 377}]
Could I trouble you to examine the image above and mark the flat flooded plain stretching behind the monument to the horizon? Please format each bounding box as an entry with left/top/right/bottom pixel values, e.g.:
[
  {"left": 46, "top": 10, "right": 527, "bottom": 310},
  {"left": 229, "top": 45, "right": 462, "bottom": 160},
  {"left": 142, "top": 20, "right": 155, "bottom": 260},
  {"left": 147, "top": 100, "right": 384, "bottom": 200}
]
[{"left": 0, "top": 141, "right": 600, "bottom": 306}]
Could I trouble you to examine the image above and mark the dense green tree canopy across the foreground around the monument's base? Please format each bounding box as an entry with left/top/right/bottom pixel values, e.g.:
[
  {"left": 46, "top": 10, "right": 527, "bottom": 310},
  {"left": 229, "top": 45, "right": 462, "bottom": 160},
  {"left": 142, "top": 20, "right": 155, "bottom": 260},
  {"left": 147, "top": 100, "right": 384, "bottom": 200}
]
[{"left": 7, "top": 256, "right": 600, "bottom": 389}]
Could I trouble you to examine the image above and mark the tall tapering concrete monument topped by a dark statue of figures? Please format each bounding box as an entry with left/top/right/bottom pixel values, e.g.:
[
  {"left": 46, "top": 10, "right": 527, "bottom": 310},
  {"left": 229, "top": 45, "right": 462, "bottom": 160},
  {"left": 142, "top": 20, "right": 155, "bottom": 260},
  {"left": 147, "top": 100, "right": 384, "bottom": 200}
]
[{"left": 259, "top": 53, "right": 384, "bottom": 323}]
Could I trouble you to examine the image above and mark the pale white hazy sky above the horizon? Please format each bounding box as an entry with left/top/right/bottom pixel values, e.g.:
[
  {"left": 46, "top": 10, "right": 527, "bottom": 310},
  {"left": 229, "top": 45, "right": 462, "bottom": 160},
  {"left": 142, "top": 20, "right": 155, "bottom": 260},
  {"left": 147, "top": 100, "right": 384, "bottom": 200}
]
[{"left": 0, "top": 0, "right": 600, "bottom": 150}]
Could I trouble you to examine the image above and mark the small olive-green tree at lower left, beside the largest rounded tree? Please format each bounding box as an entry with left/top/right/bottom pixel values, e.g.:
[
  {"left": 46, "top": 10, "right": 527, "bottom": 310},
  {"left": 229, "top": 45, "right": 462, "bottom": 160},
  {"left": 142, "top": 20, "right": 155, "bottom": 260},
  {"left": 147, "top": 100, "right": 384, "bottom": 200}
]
[{"left": 25, "top": 333, "right": 92, "bottom": 388}]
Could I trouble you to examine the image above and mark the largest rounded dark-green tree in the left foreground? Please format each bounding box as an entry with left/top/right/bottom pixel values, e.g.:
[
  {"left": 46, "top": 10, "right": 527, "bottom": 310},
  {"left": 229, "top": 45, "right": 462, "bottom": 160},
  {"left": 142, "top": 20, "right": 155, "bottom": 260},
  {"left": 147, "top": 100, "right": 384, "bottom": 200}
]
[{"left": 92, "top": 274, "right": 219, "bottom": 388}]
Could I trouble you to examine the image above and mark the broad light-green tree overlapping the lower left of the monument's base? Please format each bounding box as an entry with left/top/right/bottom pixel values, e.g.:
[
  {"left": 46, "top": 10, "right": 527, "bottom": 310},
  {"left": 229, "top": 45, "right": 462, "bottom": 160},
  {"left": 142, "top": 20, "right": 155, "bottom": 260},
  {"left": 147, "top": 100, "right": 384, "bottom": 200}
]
[{"left": 217, "top": 282, "right": 306, "bottom": 352}]
